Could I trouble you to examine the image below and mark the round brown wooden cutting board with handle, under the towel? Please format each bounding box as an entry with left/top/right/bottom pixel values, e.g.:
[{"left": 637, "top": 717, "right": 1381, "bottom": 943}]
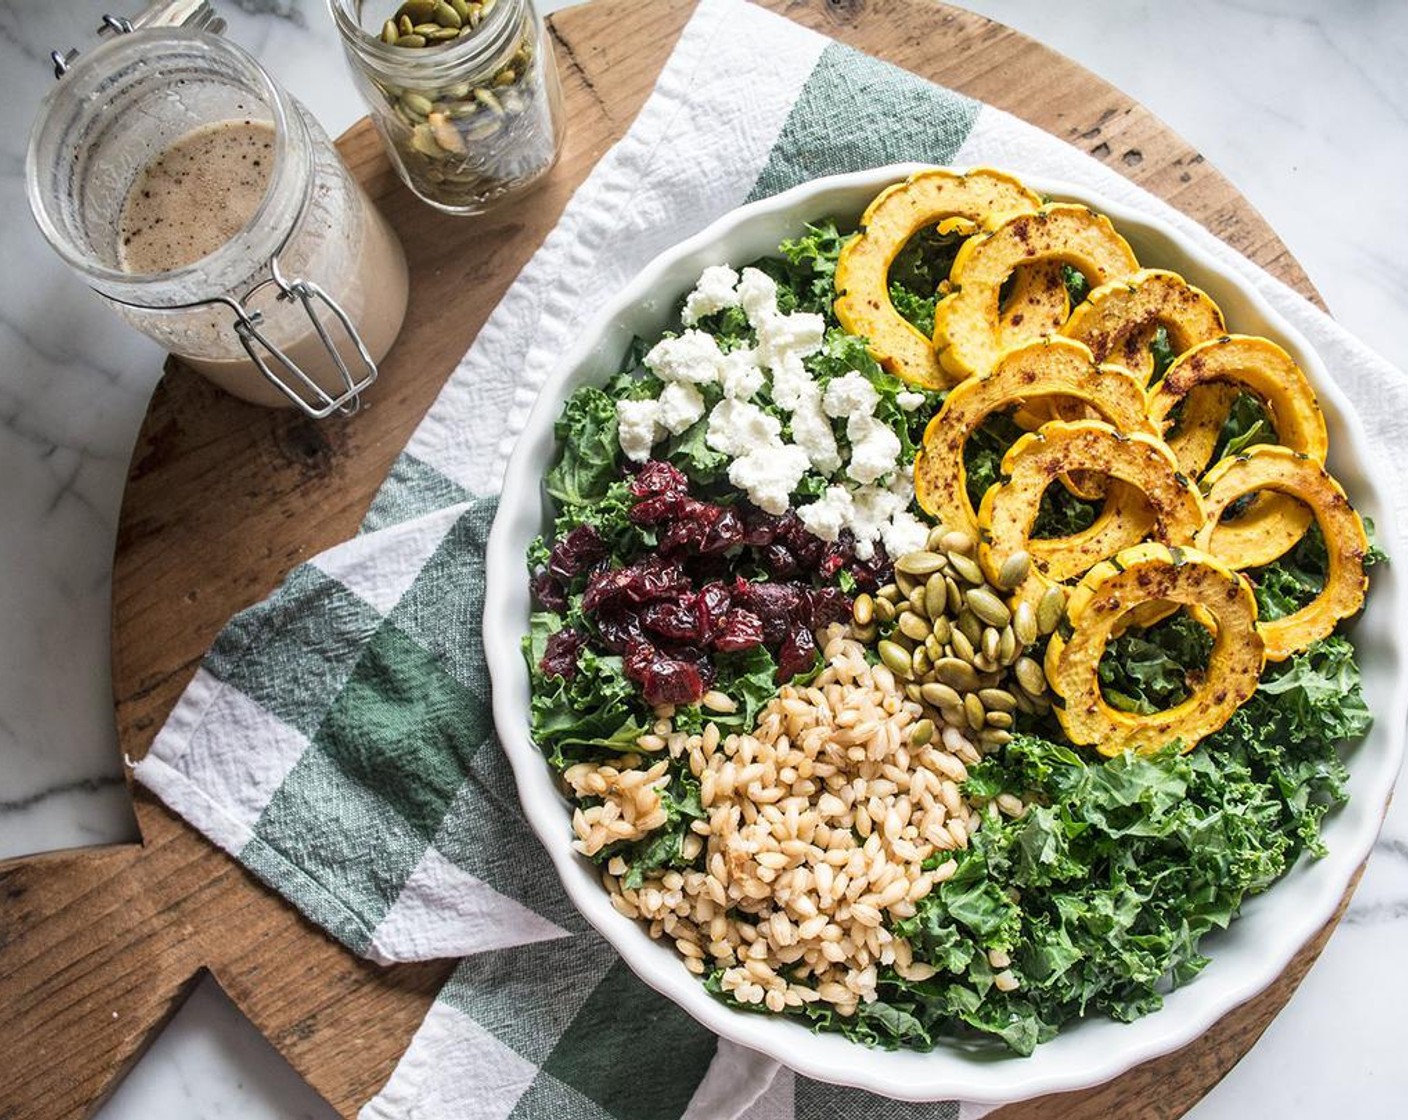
[{"left": 0, "top": 0, "right": 1347, "bottom": 1120}]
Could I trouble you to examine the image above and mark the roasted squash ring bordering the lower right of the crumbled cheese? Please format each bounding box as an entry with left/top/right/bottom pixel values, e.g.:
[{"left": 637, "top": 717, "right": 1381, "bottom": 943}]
[{"left": 914, "top": 337, "right": 1155, "bottom": 531}]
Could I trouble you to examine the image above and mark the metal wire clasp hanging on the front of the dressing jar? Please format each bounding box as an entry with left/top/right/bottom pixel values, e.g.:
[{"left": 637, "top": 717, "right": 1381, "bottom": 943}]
[{"left": 232, "top": 256, "right": 376, "bottom": 420}]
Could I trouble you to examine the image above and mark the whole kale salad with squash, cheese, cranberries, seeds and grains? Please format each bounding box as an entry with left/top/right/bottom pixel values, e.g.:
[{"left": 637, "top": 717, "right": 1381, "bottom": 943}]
[{"left": 524, "top": 169, "right": 1383, "bottom": 1055}]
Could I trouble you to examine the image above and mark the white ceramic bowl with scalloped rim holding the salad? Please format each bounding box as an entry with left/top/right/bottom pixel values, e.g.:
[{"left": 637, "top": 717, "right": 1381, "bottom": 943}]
[{"left": 484, "top": 166, "right": 1408, "bottom": 1103}]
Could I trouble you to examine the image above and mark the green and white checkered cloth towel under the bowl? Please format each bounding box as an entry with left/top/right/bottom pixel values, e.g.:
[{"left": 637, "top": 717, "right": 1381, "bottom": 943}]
[{"left": 135, "top": 0, "right": 1408, "bottom": 1120}]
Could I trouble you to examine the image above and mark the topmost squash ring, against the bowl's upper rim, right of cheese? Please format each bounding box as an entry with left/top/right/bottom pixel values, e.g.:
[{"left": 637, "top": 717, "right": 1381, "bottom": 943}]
[{"left": 835, "top": 168, "right": 1047, "bottom": 389}]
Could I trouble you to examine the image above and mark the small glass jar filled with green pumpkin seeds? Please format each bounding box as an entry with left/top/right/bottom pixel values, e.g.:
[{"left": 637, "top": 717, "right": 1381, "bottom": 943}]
[{"left": 328, "top": 0, "right": 563, "bottom": 214}]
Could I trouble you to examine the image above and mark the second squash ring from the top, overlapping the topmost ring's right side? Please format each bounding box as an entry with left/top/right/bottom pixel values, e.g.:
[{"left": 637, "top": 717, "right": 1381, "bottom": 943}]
[{"left": 934, "top": 203, "right": 1139, "bottom": 380}]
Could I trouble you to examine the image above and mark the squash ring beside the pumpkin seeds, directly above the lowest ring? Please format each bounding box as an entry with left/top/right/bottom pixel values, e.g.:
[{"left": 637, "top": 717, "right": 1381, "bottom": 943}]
[{"left": 977, "top": 420, "right": 1205, "bottom": 599}]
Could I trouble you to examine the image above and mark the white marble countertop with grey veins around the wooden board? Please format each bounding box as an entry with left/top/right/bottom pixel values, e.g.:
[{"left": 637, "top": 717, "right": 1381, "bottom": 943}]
[{"left": 0, "top": 0, "right": 1408, "bottom": 1120}]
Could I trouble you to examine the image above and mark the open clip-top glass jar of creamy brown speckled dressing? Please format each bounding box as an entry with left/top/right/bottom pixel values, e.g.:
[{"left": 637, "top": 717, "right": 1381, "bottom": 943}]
[{"left": 25, "top": 4, "right": 407, "bottom": 417}]
